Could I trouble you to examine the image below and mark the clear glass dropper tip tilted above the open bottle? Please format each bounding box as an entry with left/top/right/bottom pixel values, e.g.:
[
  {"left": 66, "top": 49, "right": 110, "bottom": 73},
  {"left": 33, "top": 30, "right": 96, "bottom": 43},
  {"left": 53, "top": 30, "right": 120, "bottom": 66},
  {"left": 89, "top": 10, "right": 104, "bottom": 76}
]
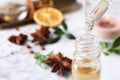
[{"left": 86, "top": 0, "right": 112, "bottom": 30}]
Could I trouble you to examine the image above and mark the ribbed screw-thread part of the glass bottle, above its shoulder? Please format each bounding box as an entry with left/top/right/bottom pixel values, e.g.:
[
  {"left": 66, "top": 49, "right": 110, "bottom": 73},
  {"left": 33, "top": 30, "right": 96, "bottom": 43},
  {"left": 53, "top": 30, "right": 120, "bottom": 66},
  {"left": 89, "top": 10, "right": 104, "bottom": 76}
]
[{"left": 75, "top": 34, "right": 100, "bottom": 57}]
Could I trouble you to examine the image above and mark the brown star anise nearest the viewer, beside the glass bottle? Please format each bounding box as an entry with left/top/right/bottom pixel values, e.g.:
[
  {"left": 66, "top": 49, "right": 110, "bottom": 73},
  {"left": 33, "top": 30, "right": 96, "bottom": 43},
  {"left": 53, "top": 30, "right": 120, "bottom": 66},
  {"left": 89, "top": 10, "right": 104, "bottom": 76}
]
[{"left": 45, "top": 52, "right": 72, "bottom": 76}]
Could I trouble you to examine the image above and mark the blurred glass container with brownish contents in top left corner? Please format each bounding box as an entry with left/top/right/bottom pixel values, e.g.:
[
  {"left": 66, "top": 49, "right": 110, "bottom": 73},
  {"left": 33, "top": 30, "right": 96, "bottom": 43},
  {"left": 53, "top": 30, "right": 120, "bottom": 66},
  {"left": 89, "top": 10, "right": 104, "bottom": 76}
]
[{"left": 0, "top": 0, "right": 28, "bottom": 22}]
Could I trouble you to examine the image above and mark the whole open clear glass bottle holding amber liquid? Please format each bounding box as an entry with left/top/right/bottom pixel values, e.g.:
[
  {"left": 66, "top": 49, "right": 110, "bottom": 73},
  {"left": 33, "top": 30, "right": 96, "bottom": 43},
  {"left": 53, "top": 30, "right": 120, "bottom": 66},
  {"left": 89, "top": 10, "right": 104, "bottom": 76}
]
[{"left": 72, "top": 34, "right": 101, "bottom": 80}]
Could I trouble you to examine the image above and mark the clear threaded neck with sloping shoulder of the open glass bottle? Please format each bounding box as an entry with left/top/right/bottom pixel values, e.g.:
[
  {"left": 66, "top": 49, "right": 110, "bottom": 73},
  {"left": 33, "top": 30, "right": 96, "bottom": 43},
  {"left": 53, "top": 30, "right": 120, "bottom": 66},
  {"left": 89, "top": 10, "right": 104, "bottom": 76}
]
[{"left": 74, "top": 34, "right": 100, "bottom": 63}]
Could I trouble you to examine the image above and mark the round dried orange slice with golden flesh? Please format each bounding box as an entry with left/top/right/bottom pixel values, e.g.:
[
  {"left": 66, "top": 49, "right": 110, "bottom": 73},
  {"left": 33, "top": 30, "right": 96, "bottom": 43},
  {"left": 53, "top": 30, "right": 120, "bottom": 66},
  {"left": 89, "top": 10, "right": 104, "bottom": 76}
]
[{"left": 33, "top": 7, "right": 63, "bottom": 27}]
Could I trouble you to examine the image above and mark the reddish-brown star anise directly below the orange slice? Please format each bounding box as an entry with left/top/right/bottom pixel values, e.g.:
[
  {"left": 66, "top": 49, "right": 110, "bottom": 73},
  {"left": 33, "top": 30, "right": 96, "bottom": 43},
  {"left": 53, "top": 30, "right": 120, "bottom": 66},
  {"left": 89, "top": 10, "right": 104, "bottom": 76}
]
[{"left": 31, "top": 26, "right": 50, "bottom": 45}]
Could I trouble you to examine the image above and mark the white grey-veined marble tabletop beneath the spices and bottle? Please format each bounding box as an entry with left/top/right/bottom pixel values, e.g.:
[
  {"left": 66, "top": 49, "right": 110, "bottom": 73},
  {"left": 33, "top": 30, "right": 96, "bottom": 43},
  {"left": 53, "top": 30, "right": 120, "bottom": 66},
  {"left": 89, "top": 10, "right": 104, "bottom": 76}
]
[{"left": 0, "top": 0, "right": 120, "bottom": 80}]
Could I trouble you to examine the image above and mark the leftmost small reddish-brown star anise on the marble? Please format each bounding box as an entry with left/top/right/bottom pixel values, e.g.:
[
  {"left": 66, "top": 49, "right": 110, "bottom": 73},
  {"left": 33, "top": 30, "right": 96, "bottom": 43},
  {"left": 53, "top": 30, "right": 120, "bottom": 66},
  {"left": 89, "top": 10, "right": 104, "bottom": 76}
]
[{"left": 8, "top": 34, "right": 28, "bottom": 45}]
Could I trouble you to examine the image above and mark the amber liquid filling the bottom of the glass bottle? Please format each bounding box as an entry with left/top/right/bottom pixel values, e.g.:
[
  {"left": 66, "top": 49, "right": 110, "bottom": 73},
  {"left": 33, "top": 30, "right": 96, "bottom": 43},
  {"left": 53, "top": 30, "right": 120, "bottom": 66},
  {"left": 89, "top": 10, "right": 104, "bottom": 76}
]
[{"left": 72, "top": 62, "right": 100, "bottom": 80}]
